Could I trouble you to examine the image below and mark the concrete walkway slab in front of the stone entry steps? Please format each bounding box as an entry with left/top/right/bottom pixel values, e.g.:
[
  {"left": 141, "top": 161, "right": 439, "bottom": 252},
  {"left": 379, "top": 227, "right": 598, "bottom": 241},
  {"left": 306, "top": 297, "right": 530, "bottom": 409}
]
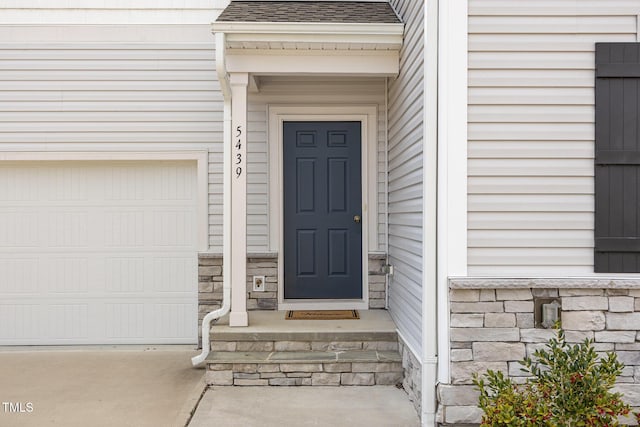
[{"left": 189, "top": 386, "right": 420, "bottom": 427}]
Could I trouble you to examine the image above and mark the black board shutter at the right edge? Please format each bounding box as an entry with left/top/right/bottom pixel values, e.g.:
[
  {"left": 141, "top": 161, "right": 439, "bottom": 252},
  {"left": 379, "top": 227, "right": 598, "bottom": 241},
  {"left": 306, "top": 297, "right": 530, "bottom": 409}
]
[{"left": 594, "top": 43, "right": 640, "bottom": 273}]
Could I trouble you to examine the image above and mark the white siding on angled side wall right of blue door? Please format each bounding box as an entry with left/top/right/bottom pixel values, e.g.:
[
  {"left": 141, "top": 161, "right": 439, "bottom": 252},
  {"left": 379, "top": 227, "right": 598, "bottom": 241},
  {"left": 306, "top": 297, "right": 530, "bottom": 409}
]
[{"left": 389, "top": 0, "right": 424, "bottom": 354}]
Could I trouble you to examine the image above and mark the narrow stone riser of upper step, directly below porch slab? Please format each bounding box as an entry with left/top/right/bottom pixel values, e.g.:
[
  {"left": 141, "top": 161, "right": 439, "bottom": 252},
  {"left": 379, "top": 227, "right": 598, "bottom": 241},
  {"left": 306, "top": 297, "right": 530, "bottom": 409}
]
[{"left": 211, "top": 340, "right": 398, "bottom": 352}]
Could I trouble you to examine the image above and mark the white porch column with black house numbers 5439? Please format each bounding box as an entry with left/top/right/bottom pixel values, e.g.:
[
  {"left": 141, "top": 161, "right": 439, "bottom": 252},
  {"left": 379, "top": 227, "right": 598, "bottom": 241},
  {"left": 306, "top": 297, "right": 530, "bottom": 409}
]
[{"left": 226, "top": 73, "right": 249, "bottom": 326}]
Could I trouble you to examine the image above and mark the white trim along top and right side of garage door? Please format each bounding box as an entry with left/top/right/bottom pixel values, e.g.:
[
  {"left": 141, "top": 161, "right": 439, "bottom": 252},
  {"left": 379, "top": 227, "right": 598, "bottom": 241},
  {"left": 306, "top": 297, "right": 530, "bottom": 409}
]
[{"left": 0, "top": 150, "right": 209, "bottom": 252}]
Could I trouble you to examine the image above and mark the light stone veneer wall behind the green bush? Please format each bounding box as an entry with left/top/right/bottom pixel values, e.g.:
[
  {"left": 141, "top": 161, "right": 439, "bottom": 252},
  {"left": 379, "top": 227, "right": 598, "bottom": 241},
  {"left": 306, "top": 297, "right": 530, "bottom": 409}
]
[{"left": 438, "top": 279, "right": 640, "bottom": 426}]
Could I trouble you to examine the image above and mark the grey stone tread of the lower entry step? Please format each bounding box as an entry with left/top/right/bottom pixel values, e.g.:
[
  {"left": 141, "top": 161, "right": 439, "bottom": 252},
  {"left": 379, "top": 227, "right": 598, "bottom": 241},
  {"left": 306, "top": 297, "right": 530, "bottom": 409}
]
[{"left": 206, "top": 350, "right": 402, "bottom": 364}]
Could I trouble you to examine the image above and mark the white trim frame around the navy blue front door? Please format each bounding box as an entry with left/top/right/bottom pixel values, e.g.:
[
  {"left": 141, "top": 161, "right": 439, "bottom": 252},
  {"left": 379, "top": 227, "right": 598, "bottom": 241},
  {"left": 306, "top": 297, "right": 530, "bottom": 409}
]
[{"left": 268, "top": 105, "right": 378, "bottom": 310}]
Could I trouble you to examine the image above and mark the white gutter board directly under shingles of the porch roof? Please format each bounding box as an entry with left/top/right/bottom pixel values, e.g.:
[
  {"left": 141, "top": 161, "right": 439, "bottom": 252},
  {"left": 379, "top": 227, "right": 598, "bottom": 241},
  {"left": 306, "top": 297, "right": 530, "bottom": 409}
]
[{"left": 212, "top": 22, "right": 404, "bottom": 49}]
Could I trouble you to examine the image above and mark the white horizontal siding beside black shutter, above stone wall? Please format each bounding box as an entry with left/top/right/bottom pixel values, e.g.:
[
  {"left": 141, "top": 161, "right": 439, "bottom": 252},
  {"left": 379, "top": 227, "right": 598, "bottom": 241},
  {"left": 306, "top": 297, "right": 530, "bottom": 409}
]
[{"left": 468, "top": 0, "right": 639, "bottom": 276}]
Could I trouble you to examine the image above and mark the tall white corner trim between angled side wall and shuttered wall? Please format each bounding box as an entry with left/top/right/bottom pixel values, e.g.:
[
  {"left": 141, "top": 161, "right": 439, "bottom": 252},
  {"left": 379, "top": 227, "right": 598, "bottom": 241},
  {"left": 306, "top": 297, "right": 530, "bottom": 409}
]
[{"left": 437, "top": 0, "right": 468, "bottom": 383}]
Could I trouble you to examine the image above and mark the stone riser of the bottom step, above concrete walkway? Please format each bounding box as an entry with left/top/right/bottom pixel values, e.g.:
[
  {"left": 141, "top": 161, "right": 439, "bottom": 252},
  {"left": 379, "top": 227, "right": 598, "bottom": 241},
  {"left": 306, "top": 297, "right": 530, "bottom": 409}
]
[{"left": 206, "top": 362, "right": 403, "bottom": 386}]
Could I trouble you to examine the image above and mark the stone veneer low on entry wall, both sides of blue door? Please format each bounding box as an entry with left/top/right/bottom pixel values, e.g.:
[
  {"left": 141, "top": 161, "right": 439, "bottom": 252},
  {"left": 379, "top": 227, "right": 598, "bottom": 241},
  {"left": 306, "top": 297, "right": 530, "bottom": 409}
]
[{"left": 198, "top": 253, "right": 387, "bottom": 336}]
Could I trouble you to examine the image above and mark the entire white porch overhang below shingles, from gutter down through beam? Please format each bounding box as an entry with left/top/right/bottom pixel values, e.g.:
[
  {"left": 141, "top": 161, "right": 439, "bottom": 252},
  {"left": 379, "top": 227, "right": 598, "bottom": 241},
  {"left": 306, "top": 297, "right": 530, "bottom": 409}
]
[{"left": 212, "top": 21, "right": 404, "bottom": 76}]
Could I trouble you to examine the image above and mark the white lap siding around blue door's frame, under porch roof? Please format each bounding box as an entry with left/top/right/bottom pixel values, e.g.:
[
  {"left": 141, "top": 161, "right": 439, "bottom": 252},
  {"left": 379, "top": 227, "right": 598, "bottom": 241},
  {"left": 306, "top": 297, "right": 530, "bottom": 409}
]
[{"left": 247, "top": 77, "right": 385, "bottom": 252}]
